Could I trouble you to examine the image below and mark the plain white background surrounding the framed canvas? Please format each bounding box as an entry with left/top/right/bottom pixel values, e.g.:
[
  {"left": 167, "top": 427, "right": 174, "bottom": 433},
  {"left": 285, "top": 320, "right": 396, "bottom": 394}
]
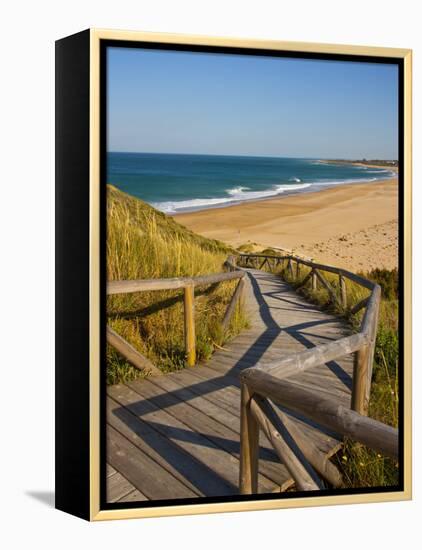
[{"left": 0, "top": 0, "right": 422, "bottom": 550}]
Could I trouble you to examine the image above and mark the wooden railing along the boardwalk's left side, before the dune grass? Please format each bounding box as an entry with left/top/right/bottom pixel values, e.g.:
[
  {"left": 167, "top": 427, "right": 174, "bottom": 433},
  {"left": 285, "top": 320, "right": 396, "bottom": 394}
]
[{"left": 107, "top": 256, "right": 245, "bottom": 375}]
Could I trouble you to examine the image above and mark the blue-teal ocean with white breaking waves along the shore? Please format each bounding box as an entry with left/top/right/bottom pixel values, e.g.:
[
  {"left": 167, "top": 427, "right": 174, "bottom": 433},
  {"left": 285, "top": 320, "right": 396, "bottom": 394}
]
[{"left": 107, "top": 152, "right": 395, "bottom": 218}]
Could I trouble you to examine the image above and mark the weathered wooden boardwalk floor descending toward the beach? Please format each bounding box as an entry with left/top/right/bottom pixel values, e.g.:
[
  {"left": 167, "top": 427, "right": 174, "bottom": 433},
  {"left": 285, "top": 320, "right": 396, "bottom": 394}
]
[{"left": 107, "top": 269, "right": 353, "bottom": 502}]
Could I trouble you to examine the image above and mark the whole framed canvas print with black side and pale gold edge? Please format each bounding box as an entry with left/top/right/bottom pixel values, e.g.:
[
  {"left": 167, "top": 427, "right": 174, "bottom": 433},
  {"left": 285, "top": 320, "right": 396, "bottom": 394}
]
[{"left": 56, "top": 30, "right": 411, "bottom": 520}]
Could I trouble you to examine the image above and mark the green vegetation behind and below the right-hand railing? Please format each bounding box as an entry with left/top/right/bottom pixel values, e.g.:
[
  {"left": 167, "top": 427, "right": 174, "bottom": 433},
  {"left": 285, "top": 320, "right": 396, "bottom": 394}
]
[{"left": 272, "top": 264, "right": 399, "bottom": 487}]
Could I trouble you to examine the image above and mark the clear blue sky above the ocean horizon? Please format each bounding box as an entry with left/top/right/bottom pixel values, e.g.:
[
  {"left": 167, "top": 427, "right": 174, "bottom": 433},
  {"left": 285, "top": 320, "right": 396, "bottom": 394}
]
[{"left": 107, "top": 48, "right": 398, "bottom": 159}]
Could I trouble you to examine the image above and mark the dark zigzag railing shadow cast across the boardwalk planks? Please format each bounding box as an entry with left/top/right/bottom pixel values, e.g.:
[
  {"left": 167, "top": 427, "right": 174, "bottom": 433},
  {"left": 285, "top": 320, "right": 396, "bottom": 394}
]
[{"left": 112, "top": 273, "right": 351, "bottom": 494}]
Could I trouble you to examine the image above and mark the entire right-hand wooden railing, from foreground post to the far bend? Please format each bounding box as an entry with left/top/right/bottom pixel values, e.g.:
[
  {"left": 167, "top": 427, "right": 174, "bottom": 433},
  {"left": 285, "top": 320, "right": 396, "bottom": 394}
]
[{"left": 238, "top": 254, "right": 398, "bottom": 494}]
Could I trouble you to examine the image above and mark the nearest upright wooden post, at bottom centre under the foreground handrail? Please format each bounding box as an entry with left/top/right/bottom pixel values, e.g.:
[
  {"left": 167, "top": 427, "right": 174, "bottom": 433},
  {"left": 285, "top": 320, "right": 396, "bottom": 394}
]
[{"left": 239, "top": 382, "right": 259, "bottom": 495}]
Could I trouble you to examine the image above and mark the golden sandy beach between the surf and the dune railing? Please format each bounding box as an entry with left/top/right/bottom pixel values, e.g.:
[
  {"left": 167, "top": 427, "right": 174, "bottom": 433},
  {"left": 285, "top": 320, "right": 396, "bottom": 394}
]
[{"left": 174, "top": 178, "right": 398, "bottom": 271}]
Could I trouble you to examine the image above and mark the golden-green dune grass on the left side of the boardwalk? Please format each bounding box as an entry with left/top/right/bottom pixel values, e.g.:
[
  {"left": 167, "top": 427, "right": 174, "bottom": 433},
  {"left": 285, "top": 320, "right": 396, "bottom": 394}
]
[{"left": 107, "top": 186, "right": 247, "bottom": 384}]
